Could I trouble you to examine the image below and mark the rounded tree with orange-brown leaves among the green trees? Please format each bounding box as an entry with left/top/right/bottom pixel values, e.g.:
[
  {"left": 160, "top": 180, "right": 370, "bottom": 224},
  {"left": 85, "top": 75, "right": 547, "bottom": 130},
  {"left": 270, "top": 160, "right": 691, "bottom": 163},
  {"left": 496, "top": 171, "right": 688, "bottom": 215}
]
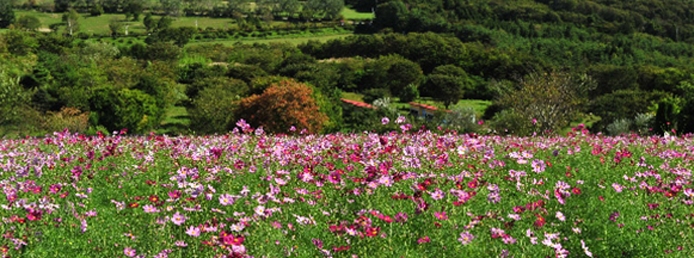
[{"left": 235, "top": 79, "right": 328, "bottom": 133}]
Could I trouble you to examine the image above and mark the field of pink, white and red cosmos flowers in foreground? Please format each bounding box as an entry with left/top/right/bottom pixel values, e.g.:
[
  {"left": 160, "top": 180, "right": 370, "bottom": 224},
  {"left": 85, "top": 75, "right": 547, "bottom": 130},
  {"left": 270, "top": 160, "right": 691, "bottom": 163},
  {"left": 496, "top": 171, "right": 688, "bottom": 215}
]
[{"left": 0, "top": 122, "right": 694, "bottom": 257}]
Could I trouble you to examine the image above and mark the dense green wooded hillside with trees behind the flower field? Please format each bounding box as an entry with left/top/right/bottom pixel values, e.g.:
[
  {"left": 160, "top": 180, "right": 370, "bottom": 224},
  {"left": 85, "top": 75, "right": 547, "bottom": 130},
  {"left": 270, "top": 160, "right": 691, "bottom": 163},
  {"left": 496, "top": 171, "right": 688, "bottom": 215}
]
[{"left": 0, "top": 0, "right": 694, "bottom": 136}]
